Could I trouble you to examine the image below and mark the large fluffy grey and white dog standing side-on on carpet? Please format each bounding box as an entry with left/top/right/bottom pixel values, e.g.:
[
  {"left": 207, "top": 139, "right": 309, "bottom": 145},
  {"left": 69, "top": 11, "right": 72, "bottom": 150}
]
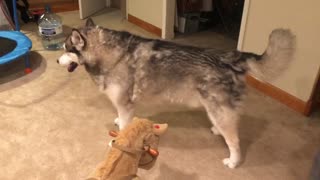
[{"left": 58, "top": 19, "right": 295, "bottom": 168}]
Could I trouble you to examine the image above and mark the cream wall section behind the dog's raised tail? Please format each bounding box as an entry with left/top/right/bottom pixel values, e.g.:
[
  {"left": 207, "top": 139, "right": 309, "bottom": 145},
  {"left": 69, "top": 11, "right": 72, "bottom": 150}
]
[{"left": 238, "top": 0, "right": 320, "bottom": 101}]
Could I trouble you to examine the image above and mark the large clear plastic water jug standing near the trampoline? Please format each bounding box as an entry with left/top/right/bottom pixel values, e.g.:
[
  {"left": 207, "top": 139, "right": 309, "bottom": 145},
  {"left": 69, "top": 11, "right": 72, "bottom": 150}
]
[{"left": 38, "top": 5, "right": 64, "bottom": 50}]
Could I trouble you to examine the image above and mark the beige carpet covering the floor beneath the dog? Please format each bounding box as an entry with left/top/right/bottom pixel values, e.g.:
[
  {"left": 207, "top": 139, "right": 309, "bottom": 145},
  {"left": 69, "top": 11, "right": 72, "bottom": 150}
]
[{"left": 0, "top": 8, "right": 320, "bottom": 180}]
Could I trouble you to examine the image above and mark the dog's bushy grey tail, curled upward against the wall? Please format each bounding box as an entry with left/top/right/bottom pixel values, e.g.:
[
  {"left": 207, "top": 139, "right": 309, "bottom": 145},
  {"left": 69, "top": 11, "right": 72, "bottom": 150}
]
[{"left": 247, "top": 29, "right": 295, "bottom": 80}]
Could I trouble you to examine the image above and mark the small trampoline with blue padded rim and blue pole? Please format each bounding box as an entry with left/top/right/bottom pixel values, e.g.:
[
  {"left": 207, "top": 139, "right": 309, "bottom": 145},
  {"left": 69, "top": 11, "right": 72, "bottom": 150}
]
[{"left": 0, "top": 0, "right": 32, "bottom": 73}]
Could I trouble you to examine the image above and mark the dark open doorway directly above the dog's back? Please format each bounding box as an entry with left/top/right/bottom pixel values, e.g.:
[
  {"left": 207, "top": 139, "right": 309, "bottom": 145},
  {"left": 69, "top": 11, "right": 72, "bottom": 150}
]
[{"left": 175, "top": 0, "right": 245, "bottom": 48}]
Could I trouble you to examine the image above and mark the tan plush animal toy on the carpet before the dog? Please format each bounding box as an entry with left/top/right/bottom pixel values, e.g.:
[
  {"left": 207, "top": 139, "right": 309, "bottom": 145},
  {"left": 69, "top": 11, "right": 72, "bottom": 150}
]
[{"left": 90, "top": 118, "right": 168, "bottom": 180}]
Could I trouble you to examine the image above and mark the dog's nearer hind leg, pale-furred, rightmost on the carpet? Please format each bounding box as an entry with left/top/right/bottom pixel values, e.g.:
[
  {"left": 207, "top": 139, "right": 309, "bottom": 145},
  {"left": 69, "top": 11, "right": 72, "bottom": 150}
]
[{"left": 202, "top": 99, "right": 241, "bottom": 168}]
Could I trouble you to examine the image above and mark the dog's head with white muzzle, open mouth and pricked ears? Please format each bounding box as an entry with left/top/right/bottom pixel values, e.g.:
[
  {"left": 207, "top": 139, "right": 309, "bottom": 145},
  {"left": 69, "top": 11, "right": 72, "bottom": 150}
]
[{"left": 57, "top": 18, "right": 95, "bottom": 72}]
